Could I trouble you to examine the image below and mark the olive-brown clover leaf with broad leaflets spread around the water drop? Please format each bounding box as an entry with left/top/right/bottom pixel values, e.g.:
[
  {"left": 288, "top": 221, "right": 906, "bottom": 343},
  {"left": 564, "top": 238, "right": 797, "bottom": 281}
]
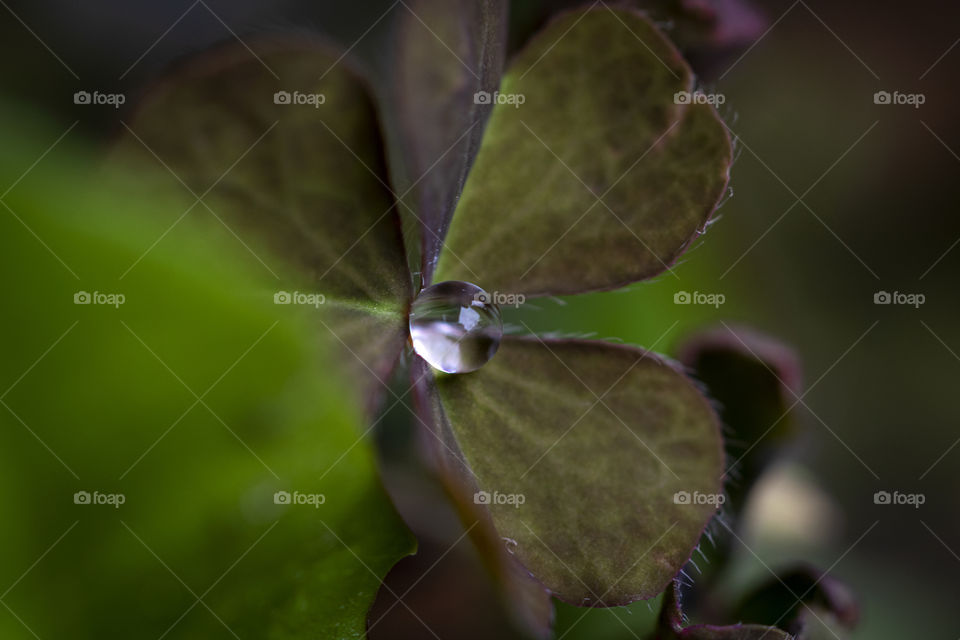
[{"left": 114, "top": 2, "right": 731, "bottom": 633}]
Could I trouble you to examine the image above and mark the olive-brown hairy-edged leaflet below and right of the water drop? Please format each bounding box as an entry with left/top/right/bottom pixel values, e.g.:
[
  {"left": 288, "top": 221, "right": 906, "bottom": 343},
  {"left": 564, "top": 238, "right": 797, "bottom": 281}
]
[{"left": 437, "top": 338, "right": 723, "bottom": 606}]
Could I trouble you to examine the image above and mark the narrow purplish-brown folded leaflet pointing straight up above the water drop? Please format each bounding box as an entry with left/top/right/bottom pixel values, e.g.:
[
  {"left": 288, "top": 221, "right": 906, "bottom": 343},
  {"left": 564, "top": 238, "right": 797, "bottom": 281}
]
[{"left": 386, "top": 0, "right": 507, "bottom": 285}]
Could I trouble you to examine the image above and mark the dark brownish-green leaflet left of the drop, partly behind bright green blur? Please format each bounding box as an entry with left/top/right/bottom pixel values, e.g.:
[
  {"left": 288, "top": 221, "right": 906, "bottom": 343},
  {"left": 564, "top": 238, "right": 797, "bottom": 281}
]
[{"left": 113, "top": 36, "right": 411, "bottom": 404}]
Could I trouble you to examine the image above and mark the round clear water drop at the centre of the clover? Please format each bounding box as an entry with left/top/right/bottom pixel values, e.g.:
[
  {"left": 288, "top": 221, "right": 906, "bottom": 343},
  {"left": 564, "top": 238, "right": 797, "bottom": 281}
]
[{"left": 410, "top": 280, "right": 503, "bottom": 373}]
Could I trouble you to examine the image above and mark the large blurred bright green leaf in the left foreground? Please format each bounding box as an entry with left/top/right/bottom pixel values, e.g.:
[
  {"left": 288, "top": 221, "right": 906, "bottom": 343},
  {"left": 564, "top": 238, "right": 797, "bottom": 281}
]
[{"left": 0, "top": 120, "right": 414, "bottom": 640}]
